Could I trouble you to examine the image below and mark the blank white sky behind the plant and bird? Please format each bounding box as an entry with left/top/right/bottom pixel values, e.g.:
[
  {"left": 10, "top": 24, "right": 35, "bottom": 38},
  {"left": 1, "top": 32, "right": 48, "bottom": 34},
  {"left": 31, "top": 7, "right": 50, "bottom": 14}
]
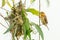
[{"left": 0, "top": 0, "right": 60, "bottom": 40}]
